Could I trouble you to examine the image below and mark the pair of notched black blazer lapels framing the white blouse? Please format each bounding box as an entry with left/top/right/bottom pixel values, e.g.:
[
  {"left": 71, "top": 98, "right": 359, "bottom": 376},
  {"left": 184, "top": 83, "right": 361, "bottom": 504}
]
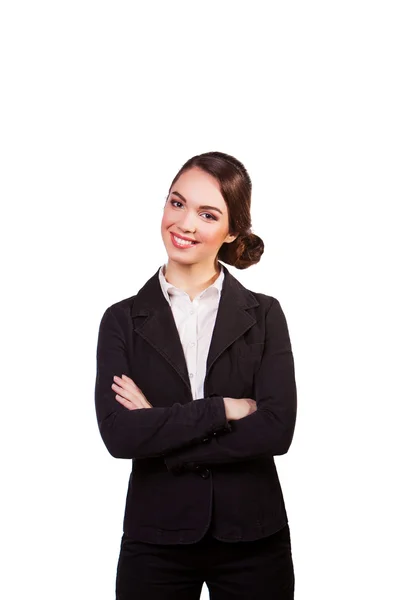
[{"left": 131, "top": 263, "right": 259, "bottom": 390}]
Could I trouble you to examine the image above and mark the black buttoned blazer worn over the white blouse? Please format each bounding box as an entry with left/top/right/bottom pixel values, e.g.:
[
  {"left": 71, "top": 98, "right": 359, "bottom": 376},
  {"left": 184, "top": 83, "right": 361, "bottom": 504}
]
[{"left": 95, "top": 263, "right": 297, "bottom": 544}]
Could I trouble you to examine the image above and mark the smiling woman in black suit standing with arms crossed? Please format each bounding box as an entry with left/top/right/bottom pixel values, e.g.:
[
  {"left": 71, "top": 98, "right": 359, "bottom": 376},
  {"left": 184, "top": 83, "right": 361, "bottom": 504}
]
[{"left": 95, "top": 152, "right": 297, "bottom": 600}]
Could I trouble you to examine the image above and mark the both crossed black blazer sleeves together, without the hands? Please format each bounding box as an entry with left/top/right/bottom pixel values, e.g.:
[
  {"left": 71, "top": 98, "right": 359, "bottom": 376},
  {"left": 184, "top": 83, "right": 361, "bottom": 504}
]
[{"left": 95, "top": 299, "right": 297, "bottom": 472}]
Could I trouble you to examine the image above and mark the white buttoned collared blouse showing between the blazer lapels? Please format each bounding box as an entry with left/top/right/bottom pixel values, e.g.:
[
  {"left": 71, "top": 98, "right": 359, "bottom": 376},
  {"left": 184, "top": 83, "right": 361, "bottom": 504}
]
[{"left": 158, "top": 265, "right": 225, "bottom": 400}]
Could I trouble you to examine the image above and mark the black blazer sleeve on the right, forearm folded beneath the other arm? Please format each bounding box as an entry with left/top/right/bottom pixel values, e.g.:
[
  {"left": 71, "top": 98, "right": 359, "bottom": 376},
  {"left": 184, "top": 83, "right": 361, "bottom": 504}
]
[{"left": 164, "top": 298, "right": 297, "bottom": 472}]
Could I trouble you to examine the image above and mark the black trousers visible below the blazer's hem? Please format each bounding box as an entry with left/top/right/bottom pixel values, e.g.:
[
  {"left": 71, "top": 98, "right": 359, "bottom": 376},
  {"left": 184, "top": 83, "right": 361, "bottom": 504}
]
[{"left": 116, "top": 524, "right": 295, "bottom": 600}]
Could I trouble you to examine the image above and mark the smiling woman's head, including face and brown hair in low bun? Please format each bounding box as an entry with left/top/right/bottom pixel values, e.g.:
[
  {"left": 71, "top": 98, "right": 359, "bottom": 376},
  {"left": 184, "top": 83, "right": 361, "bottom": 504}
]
[{"left": 161, "top": 152, "right": 264, "bottom": 271}]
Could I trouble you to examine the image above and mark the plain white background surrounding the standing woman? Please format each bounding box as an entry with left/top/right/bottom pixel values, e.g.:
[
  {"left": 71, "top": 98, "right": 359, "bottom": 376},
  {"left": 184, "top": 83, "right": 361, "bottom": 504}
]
[{"left": 0, "top": 0, "right": 400, "bottom": 600}]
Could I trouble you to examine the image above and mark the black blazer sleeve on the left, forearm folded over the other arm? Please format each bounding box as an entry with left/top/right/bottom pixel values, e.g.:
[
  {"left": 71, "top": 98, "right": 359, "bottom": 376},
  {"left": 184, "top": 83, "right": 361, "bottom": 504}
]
[{"left": 95, "top": 306, "right": 230, "bottom": 459}]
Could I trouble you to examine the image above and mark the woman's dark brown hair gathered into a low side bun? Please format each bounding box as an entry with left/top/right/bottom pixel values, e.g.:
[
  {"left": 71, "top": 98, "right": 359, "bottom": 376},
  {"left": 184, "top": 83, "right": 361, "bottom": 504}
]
[{"left": 168, "top": 152, "right": 264, "bottom": 269}]
